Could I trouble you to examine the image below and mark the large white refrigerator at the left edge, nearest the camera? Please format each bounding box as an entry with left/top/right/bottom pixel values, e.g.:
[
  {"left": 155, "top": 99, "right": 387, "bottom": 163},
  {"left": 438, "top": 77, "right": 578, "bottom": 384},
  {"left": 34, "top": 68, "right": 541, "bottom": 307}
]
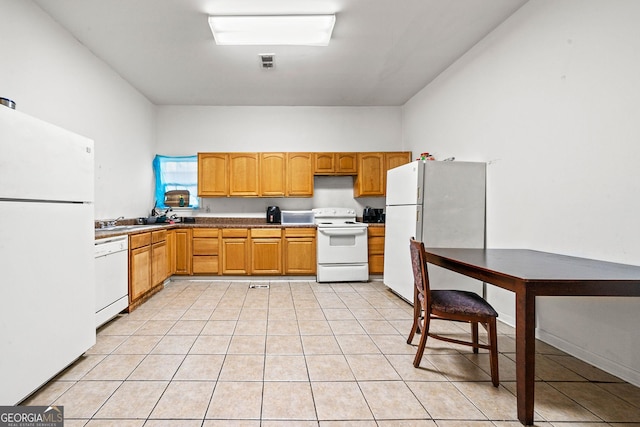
[{"left": 0, "top": 106, "right": 96, "bottom": 405}]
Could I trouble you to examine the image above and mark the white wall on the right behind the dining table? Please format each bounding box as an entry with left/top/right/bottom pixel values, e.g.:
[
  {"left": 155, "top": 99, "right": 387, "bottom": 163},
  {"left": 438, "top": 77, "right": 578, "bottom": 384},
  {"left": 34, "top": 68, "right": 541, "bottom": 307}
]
[{"left": 403, "top": 0, "right": 640, "bottom": 385}]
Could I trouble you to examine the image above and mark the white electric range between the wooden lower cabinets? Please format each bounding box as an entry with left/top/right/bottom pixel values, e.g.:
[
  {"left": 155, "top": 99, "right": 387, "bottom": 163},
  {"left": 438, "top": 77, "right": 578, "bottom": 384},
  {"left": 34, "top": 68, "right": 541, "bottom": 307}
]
[{"left": 313, "top": 208, "right": 369, "bottom": 282}]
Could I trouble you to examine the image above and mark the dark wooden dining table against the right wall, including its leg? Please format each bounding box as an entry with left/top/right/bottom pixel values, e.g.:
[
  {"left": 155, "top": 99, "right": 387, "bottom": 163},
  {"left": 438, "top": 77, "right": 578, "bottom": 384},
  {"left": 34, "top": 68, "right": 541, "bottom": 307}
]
[{"left": 426, "top": 248, "right": 640, "bottom": 425}]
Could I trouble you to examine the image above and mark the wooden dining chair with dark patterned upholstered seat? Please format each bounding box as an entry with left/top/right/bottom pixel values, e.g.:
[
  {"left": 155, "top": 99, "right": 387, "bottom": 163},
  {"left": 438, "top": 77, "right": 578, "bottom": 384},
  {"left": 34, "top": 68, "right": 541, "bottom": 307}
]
[{"left": 407, "top": 238, "right": 499, "bottom": 387}]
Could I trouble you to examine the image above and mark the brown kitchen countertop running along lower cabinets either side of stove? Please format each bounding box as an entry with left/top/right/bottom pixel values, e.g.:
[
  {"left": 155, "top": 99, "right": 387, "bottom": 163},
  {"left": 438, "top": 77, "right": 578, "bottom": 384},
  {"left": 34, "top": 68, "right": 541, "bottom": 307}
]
[{"left": 95, "top": 217, "right": 384, "bottom": 239}]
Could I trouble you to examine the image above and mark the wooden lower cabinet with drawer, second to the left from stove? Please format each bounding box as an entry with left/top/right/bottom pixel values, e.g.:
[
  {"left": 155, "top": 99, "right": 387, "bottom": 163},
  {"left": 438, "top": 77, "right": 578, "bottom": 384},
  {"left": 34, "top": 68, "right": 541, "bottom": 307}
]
[{"left": 250, "top": 228, "right": 283, "bottom": 275}]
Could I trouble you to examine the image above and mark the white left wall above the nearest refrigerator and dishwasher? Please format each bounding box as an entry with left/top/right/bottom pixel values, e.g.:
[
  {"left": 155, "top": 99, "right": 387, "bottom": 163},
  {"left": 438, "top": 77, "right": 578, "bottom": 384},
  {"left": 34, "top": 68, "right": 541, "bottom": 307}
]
[{"left": 0, "top": 0, "right": 155, "bottom": 219}]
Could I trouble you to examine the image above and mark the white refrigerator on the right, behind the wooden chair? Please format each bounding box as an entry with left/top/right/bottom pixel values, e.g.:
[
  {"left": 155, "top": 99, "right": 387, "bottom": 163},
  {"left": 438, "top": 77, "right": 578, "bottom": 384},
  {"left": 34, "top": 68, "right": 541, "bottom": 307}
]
[{"left": 384, "top": 160, "right": 486, "bottom": 302}]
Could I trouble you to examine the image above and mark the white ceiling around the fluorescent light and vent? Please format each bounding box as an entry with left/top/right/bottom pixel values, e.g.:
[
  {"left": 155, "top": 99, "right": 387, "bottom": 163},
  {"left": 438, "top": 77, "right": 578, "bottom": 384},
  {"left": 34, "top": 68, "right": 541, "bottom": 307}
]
[{"left": 34, "top": 0, "right": 527, "bottom": 106}]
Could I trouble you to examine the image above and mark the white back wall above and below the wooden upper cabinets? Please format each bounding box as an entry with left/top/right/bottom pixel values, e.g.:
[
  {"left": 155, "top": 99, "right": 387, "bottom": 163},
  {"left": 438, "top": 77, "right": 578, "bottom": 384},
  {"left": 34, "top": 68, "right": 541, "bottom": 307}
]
[{"left": 157, "top": 106, "right": 402, "bottom": 216}]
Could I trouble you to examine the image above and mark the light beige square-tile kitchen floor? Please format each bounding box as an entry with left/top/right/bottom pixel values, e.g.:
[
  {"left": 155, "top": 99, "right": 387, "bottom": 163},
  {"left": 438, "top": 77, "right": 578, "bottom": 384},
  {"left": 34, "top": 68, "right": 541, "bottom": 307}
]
[{"left": 23, "top": 280, "right": 640, "bottom": 427}]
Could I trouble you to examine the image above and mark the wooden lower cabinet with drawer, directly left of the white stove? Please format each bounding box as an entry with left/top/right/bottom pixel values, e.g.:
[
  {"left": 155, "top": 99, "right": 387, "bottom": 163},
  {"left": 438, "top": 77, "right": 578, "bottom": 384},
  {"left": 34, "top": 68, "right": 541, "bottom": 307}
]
[{"left": 284, "top": 228, "right": 316, "bottom": 274}]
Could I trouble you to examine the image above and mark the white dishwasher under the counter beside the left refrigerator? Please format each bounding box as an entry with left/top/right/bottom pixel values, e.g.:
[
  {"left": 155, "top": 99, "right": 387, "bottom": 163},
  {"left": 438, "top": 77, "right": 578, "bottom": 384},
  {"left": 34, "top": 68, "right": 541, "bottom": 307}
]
[{"left": 95, "top": 236, "right": 129, "bottom": 328}]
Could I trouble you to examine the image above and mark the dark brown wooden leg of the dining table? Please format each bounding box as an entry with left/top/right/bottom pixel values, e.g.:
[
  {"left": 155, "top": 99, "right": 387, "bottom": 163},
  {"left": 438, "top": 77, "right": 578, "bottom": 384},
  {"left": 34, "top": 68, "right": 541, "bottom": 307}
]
[{"left": 516, "top": 288, "right": 536, "bottom": 425}]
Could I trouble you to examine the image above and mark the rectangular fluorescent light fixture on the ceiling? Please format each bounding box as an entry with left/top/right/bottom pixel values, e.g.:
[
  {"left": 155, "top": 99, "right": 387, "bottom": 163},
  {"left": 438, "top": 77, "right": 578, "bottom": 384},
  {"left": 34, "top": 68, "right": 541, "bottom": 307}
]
[{"left": 209, "top": 15, "right": 336, "bottom": 46}]
